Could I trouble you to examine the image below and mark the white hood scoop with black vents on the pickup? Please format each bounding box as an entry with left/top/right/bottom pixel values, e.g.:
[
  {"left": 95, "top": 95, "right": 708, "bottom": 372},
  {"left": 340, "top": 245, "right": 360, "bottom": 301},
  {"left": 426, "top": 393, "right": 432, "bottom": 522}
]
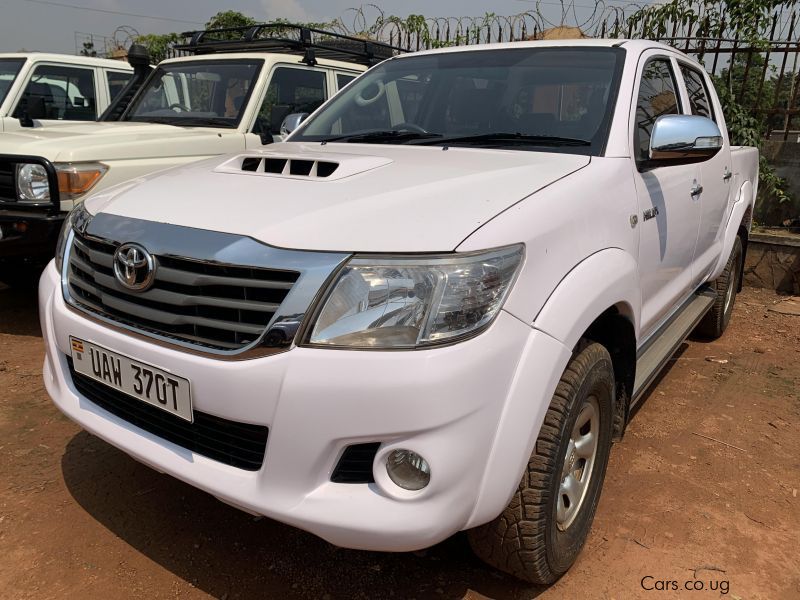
[{"left": 214, "top": 152, "right": 392, "bottom": 181}]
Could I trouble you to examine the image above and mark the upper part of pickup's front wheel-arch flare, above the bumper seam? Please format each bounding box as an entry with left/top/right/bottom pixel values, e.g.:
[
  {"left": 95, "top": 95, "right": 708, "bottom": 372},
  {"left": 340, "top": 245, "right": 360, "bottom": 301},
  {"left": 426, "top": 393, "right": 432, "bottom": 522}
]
[{"left": 533, "top": 248, "right": 642, "bottom": 348}]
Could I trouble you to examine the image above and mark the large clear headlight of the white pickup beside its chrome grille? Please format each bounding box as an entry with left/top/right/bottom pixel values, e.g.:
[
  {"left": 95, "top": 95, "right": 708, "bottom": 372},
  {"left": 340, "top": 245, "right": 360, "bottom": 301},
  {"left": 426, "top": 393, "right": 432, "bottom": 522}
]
[{"left": 308, "top": 245, "right": 524, "bottom": 348}]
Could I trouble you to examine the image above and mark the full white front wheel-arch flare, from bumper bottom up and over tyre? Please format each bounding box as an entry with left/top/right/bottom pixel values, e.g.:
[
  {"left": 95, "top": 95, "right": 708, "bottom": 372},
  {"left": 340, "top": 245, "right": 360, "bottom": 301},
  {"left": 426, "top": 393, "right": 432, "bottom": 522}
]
[{"left": 465, "top": 248, "right": 641, "bottom": 529}]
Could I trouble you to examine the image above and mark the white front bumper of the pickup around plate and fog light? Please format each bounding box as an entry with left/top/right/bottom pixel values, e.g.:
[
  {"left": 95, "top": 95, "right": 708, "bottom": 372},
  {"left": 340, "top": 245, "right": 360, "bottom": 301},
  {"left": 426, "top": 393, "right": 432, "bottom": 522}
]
[{"left": 39, "top": 263, "right": 569, "bottom": 551}]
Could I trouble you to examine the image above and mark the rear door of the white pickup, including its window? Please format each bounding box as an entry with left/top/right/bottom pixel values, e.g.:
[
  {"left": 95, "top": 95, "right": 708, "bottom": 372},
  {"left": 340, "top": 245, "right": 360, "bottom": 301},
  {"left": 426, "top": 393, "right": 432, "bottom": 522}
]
[{"left": 678, "top": 60, "right": 733, "bottom": 286}]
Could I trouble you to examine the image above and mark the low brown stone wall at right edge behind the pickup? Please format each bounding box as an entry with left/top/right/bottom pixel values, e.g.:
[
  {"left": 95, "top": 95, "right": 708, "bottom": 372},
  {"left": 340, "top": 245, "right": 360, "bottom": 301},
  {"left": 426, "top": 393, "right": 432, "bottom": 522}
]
[{"left": 744, "top": 233, "right": 800, "bottom": 294}]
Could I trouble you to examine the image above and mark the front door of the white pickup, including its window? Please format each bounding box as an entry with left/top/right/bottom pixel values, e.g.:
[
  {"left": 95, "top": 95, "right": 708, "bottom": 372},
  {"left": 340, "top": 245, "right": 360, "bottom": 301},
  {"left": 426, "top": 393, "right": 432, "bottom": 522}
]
[{"left": 630, "top": 50, "right": 701, "bottom": 339}]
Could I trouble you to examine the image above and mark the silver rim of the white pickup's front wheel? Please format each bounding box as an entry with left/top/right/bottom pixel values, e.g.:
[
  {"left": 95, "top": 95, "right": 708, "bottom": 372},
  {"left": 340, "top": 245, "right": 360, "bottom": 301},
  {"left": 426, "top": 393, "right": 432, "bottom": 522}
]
[{"left": 556, "top": 395, "right": 600, "bottom": 531}]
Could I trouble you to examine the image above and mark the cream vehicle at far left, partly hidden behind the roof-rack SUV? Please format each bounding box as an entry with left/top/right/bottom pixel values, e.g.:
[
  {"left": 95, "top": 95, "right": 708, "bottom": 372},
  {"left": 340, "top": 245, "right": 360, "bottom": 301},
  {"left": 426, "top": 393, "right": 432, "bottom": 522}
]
[{"left": 0, "top": 52, "right": 133, "bottom": 131}]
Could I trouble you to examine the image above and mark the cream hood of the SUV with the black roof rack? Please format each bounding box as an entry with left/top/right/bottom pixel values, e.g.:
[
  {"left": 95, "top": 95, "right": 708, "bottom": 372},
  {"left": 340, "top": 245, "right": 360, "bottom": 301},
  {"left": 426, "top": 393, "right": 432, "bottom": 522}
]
[{"left": 0, "top": 121, "right": 244, "bottom": 162}]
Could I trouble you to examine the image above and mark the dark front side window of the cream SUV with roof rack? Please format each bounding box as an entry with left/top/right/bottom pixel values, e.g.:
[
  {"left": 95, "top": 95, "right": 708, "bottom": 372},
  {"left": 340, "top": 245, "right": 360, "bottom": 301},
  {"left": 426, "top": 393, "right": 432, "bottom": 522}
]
[{"left": 253, "top": 67, "right": 327, "bottom": 134}]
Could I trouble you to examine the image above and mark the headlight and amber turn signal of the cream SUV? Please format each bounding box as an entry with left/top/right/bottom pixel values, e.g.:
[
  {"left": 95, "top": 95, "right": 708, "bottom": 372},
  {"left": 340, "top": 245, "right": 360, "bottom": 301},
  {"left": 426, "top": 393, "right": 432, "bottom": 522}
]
[{"left": 17, "top": 162, "right": 108, "bottom": 203}]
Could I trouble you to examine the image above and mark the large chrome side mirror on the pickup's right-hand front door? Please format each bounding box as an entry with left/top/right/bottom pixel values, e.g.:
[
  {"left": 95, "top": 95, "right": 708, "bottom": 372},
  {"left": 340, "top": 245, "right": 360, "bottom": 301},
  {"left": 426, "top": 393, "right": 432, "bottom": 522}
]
[{"left": 650, "top": 115, "right": 722, "bottom": 164}]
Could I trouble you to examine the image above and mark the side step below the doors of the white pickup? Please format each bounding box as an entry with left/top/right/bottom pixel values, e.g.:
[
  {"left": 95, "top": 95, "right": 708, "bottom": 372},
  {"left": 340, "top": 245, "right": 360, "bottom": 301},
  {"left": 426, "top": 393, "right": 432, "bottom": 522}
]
[{"left": 630, "top": 288, "right": 717, "bottom": 408}]
